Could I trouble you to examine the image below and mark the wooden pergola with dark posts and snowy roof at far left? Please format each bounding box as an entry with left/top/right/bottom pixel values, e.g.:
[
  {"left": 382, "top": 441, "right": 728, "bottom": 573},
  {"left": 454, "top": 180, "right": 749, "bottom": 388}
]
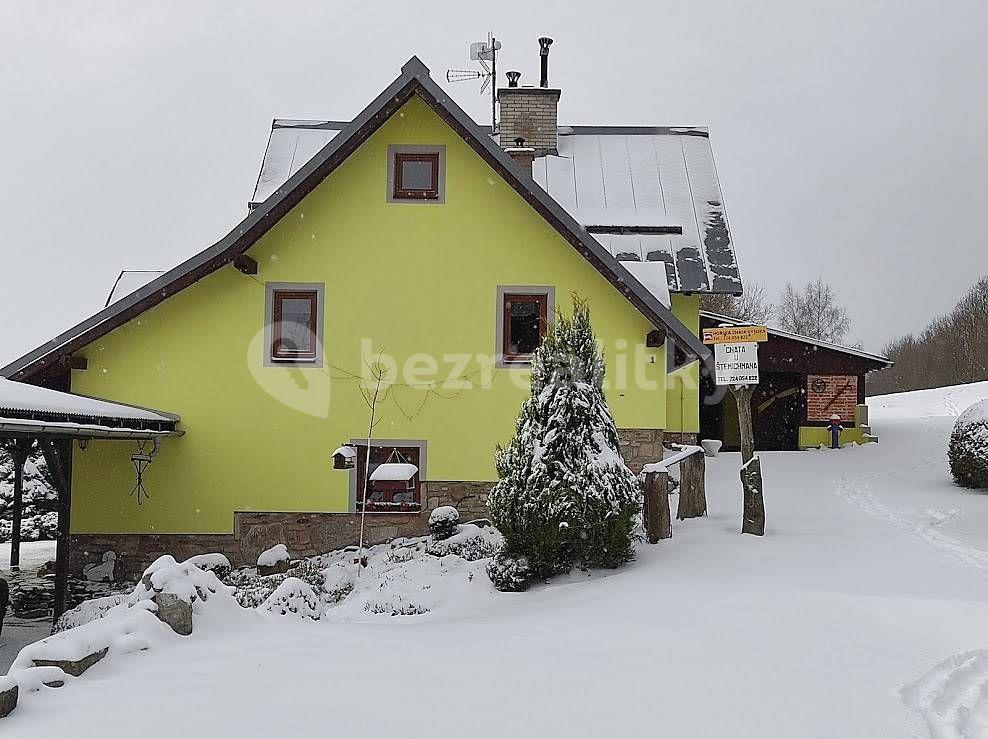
[{"left": 0, "top": 379, "right": 184, "bottom": 620}]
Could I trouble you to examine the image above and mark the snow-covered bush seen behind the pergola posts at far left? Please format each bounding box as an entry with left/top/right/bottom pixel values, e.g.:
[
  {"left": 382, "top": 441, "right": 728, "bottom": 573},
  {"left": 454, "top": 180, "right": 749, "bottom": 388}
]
[{"left": 0, "top": 441, "right": 58, "bottom": 542}]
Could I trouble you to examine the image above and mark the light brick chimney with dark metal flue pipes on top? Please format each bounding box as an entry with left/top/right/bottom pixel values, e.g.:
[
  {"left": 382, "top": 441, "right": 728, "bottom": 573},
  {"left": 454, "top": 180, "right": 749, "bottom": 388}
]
[{"left": 497, "top": 37, "right": 561, "bottom": 156}]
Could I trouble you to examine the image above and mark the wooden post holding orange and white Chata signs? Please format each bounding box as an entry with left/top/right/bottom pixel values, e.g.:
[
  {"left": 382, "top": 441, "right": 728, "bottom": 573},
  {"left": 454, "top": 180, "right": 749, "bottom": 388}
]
[{"left": 703, "top": 326, "right": 768, "bottom": 536}]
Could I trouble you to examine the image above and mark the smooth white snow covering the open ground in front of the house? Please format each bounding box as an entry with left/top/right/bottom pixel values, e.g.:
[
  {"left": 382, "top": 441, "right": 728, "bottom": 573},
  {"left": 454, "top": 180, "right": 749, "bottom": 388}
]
[{"left": 0, "top": 383, "right": 988, "bottom": 739}]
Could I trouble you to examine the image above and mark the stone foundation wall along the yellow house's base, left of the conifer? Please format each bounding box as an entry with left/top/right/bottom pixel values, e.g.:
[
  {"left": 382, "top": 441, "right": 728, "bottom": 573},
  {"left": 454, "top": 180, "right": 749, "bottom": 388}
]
[{"left": 69, "top": 481, "right": 494, "bottom": 580}]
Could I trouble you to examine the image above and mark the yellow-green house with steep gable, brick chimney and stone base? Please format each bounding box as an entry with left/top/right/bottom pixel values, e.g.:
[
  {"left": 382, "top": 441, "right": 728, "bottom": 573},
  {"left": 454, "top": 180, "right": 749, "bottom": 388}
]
[{"left": 0, "top": 57, "right": 740, "bottom": 577}]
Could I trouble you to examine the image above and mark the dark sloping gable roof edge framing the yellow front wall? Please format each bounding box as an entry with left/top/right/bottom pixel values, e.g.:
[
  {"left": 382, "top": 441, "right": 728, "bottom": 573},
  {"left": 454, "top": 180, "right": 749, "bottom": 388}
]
[{"left": 0, "top": 56, "right": 710, "bottom": 380}]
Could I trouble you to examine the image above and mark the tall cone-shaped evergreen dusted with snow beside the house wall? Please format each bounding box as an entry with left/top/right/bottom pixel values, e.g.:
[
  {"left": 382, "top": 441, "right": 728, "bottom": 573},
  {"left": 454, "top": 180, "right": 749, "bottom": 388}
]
[{"left": 488, "top": 299, "right": 641, "bottom": 584}]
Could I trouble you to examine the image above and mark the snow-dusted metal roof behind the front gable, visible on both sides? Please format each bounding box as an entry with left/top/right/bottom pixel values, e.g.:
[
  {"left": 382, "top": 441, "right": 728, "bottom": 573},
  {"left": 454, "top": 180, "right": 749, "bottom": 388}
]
[{"left": 251, "top": 119, "right": 741, "bottom": 296}]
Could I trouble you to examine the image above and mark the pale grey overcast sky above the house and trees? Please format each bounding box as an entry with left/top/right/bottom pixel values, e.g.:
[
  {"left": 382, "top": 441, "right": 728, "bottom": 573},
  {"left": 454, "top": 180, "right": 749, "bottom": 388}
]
[{"left": 0, "top": 0, "right": 988, "bottom": 364}]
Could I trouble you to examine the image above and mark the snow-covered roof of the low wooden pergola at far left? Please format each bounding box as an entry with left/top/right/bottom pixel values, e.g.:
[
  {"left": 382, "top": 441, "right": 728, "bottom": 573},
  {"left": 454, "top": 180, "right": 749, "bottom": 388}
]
[{"left": 0, "top": 378, "right": 179, "bottom": 425}]
